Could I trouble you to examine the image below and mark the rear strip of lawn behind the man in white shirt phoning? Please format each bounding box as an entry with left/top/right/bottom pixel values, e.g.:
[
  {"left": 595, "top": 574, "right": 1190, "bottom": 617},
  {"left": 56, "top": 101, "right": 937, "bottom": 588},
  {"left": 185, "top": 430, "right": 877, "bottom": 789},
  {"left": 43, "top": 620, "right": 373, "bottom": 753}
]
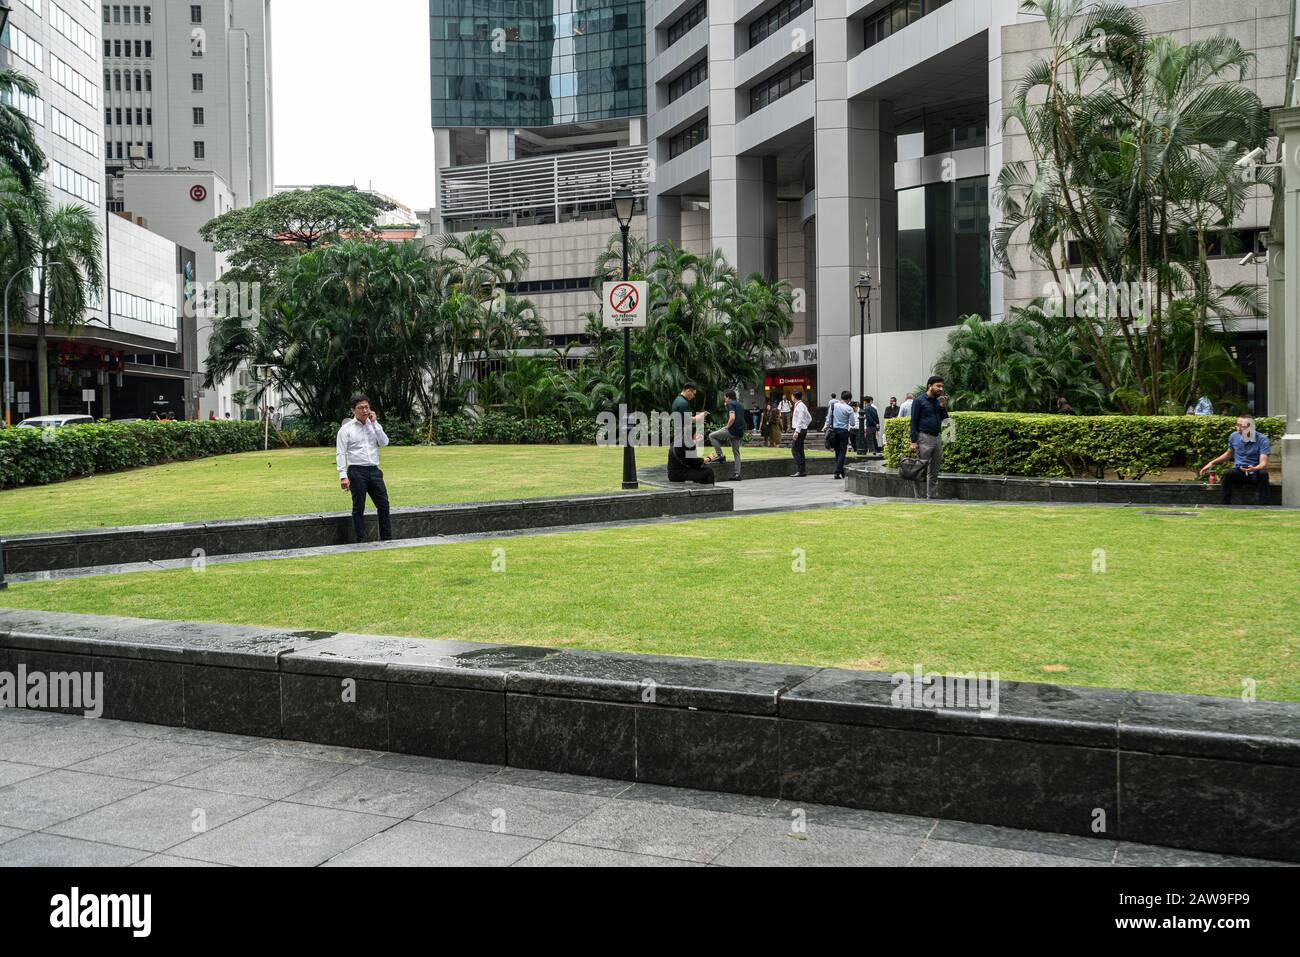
[{"left": 0, "top": 445, "right": 790, "bottom": 534}]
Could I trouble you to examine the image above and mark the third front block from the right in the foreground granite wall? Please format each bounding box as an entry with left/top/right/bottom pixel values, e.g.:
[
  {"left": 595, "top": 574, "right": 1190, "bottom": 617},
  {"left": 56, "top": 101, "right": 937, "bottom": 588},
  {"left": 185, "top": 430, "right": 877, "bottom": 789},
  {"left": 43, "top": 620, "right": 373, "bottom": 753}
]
[{"left": 780, "top": 718, "right": 943, "bottom": 817}]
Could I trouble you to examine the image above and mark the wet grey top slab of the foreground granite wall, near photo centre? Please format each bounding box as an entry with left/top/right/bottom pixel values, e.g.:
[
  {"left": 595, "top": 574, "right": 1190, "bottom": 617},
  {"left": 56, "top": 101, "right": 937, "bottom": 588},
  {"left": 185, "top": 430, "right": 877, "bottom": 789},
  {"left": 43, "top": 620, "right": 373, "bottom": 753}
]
[{"left": 507, "top": 650, "right": 818, "bottom": 715}]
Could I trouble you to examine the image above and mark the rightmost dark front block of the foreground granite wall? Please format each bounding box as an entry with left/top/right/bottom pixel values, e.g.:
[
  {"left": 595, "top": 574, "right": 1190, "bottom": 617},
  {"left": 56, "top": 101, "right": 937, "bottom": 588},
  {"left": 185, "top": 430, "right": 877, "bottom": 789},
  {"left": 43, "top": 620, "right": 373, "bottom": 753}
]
[{"left": 1119, "top": 750, "right": 1300, "bottom": 861}]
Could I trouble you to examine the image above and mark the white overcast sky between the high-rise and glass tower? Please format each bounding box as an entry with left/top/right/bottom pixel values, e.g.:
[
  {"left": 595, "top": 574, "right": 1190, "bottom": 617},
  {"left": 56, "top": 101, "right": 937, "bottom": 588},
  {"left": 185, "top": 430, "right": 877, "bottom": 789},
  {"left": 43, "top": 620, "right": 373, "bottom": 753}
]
[{"left": 270, "top": 0, "right": 434, "bottom": 209}]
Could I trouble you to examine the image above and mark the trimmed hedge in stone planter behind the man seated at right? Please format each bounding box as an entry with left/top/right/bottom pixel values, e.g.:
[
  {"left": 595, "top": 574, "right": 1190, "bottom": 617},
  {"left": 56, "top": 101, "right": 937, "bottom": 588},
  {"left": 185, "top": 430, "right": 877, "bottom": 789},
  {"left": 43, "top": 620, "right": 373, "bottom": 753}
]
[{"left": 885, "top": 412, "right": 1284, "bottom": 480}]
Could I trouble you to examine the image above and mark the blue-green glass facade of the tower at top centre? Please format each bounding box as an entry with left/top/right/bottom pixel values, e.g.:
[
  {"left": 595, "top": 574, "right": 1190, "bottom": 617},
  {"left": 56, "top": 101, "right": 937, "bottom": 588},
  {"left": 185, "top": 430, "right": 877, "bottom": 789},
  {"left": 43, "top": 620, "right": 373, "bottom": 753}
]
[{"left": 429, "top": 0, "right": 646, "bottom": 127}]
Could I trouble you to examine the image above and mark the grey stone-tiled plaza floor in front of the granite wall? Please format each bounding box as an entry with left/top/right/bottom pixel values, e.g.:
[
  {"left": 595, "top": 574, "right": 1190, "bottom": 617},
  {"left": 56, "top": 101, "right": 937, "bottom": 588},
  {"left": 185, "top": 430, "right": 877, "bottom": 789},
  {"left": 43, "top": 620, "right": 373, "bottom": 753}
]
[{"left": 0, "top": 710, "right": 1271, "bottom": 867}]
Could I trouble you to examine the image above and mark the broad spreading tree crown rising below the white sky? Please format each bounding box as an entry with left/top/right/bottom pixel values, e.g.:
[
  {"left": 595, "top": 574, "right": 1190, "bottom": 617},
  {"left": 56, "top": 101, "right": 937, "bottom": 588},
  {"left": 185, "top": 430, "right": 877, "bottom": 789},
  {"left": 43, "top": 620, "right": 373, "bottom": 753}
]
[{"left": 199, "top": 186, "right": 394, "bottom": 283}]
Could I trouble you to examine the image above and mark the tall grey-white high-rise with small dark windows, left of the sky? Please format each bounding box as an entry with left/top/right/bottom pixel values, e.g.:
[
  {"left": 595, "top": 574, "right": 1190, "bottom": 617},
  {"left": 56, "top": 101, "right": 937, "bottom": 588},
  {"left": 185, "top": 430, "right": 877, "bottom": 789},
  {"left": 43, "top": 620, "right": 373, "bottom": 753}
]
[{"left": 102, "top": 0, "right": 274, "bottom": 208}]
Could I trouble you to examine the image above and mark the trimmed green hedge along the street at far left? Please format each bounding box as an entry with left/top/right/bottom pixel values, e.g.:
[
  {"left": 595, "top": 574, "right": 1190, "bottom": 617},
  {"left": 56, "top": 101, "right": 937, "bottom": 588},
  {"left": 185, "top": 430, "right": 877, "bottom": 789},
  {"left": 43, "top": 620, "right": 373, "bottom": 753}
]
[{"left": 0, "top": 421, "right": 263, "bottom": 489}]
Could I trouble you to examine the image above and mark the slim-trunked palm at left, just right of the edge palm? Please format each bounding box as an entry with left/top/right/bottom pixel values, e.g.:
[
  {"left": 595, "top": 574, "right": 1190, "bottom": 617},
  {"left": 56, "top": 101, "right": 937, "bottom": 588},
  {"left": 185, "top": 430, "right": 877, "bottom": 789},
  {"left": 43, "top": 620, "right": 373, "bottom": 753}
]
[{"left": 31, "top": 196, "right": 104, "bottom": 415}]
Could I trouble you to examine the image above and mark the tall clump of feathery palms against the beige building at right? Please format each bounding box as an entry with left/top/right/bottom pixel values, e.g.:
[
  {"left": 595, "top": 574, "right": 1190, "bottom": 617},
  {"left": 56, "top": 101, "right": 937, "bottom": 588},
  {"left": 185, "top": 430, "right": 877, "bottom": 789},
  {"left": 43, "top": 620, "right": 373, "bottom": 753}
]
[{"left": 993, "top": 0, "right": 1269, "bottom": 412}]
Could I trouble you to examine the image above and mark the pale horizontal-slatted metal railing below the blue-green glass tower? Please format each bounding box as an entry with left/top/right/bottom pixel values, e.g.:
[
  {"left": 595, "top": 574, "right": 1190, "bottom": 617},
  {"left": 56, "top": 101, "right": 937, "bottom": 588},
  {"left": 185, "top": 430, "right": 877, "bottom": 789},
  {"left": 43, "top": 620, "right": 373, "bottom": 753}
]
[{"left": 438, "top": 146, "right": 651, "bottom": 222}]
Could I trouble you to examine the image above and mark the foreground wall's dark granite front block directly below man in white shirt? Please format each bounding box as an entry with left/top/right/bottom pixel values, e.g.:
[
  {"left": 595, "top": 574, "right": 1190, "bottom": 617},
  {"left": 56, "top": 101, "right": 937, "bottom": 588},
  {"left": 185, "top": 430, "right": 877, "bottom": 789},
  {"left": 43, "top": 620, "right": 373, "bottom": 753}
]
[{"left": 280, "top": 675, "right": 389, "bottom": 750}]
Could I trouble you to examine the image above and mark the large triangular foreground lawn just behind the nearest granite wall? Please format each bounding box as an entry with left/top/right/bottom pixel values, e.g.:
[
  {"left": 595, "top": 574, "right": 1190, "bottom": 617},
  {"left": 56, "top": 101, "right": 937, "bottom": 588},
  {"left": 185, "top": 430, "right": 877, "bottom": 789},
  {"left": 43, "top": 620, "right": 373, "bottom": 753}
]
[{"left": 0, "top": 503, "right": 1300, "bottom": 701}]
